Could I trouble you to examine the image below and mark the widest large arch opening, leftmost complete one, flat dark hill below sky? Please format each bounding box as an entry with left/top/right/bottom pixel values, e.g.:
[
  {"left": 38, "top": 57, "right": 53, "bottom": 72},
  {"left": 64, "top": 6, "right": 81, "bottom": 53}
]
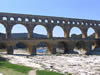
[{"left": 11, "top": 24, "right": 28, "bottom": 39}]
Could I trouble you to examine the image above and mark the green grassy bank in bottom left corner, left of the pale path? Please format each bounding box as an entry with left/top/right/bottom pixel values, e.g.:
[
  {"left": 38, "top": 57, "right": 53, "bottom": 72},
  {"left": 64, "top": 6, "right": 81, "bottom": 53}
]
[{"left": 0, "top": 57, "right": 32, "bottom": 75}]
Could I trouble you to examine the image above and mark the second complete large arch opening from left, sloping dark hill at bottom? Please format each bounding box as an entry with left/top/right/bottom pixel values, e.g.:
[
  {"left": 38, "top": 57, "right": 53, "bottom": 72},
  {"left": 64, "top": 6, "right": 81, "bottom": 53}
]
[{"left": 33, "top": 25, "right": 49, "bottom": 38}]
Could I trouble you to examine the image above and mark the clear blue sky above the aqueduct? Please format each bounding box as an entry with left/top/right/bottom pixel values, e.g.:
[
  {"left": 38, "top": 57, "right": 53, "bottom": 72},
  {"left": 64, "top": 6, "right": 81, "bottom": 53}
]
[{"left": 0, "top": 0, "right": 100, "bottom": 35}]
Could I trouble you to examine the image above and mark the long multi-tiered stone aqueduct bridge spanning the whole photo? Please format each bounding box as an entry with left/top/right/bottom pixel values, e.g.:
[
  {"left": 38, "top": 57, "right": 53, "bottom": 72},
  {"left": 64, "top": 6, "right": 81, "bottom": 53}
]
[{"left": 0, "top": 13, "right": 100, "bottom": 55}]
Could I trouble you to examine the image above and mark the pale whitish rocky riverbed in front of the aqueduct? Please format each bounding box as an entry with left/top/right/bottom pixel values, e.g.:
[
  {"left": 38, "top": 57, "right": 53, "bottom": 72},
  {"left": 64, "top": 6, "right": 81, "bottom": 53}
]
[{"left": 1, "top": 50, "right": 100, "bottom": 75}]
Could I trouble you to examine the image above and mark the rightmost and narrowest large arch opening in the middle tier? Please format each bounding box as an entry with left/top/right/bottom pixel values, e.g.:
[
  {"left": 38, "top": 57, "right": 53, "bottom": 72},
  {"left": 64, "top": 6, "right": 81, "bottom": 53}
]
[{"left": 87, "top": 27, "right": 98, "bottom": 38}]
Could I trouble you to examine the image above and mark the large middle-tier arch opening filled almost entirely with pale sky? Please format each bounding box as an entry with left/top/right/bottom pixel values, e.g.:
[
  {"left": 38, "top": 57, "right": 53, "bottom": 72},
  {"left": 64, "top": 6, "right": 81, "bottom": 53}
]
[{"left": 52, "top": 26, "right": 67, "bottom": 37}]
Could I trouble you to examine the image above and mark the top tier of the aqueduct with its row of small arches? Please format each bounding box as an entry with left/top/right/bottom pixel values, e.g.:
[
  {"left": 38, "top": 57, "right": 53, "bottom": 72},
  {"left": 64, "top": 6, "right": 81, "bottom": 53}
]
[{"left": 0, "top": 13, "right": 100, "bottom": 26}]
